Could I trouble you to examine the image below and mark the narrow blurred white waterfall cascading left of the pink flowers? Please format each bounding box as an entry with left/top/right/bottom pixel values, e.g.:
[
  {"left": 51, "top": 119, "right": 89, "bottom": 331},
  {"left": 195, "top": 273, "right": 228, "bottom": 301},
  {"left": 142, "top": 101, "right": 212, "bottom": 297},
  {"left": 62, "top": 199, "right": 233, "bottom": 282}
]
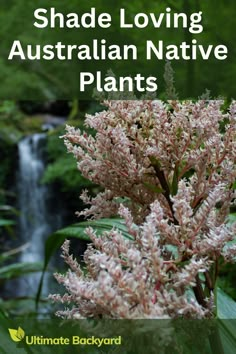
[{"left": 17, "top": 134, "right": 61, "bottom": 296}]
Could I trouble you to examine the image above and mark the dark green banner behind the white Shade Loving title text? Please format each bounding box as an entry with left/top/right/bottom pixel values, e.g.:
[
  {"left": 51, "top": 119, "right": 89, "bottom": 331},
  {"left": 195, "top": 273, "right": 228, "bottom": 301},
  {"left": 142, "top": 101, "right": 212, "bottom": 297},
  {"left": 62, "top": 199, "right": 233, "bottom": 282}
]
[{"left": 0, "top": 0, "right": 236, "bottom": 100}]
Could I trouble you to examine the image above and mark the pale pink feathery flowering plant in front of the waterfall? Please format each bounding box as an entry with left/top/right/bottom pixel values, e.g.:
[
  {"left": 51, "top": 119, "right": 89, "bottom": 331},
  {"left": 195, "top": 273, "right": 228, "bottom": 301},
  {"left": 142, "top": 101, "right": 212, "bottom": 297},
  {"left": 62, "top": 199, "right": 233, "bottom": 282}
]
[{"left": 48, "top": 100, "right": 236, "bottom": 319}]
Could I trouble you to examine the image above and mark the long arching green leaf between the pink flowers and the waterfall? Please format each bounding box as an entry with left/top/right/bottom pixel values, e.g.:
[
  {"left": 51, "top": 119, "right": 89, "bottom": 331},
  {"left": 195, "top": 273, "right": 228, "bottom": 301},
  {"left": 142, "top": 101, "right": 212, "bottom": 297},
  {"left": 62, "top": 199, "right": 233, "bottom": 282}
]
[{"left": 36, "top": 218, "right": 133, "bottom": 304}]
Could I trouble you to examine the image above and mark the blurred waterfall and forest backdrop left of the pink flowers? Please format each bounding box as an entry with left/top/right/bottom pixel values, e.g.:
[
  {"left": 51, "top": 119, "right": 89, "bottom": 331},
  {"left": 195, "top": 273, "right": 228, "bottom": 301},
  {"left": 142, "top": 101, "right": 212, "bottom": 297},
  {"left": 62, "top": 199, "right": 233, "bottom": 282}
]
[{"left": 0, "top": 100, "right": 101, "bottom": 316}]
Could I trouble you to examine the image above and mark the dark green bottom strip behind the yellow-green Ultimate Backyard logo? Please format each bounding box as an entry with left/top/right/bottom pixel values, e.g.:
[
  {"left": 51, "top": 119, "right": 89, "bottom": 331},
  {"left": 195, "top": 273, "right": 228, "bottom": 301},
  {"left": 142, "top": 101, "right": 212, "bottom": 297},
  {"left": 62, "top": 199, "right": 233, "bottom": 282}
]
[{"left": 0, "top": 319, "right": 236, "bottom": 354}]
